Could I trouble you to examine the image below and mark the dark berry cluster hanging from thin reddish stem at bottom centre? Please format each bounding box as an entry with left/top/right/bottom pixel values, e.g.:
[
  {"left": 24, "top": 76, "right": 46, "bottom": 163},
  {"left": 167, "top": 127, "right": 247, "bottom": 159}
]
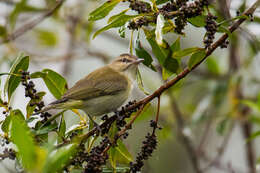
[{"left": 130, "top": 133, "right": 157, "bottom": 173}]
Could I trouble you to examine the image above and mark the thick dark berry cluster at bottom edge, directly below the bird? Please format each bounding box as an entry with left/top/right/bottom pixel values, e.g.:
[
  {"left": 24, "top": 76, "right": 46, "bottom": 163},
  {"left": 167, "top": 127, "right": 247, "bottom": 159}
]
[{"left": 83, "top": 137, "right": 111, "bottom": 173}]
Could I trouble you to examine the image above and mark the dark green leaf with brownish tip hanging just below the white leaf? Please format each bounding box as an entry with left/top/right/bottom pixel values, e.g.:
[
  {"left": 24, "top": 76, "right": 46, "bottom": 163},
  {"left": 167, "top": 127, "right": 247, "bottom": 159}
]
[{"left": 144, "top": 29, "right": 170, "bottom": 65}]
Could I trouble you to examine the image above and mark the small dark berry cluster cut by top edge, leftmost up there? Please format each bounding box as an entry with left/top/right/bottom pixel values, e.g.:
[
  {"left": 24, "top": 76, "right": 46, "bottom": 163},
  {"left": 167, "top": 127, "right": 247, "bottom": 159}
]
[{"left": 129, "top": 0, "right": 152, "bottom": 14}]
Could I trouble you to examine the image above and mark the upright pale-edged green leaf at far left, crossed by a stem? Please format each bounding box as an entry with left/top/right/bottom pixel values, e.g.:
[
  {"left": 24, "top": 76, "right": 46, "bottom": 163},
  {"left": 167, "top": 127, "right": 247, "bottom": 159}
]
[{"left": 4, "top": 55, "right": 29, "bottom": 101}]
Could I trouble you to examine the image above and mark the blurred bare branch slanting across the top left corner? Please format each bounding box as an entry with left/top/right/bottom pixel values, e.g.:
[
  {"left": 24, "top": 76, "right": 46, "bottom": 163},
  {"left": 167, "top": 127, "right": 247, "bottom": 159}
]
[{"left": 0, "top": 0, "right": 64, "bottom": 44}]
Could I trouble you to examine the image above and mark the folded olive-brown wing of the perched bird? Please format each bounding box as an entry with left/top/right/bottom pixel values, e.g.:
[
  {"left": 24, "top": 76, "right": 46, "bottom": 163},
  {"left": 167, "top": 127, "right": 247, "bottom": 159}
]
[{"left": 63, "top": 67, "right": 128, "bottom": 100}]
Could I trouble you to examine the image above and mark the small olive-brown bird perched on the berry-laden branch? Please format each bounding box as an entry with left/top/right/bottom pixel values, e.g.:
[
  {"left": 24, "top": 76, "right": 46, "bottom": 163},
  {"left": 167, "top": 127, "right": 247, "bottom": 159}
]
[{"left": 41, "top": 54, "right": 143, "bottom": 126}]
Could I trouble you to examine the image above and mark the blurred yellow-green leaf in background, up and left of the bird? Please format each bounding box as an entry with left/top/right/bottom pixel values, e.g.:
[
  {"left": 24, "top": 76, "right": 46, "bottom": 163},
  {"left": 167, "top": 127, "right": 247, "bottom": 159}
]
[{"left": 34, "top": 29, "right": 58, "bottom": 46}]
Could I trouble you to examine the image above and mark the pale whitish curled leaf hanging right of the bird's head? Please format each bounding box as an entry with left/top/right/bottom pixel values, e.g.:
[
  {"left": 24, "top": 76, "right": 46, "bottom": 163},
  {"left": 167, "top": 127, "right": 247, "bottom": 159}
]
[{"left": 155, "top": 14, "right": 164, "bottom": 46}]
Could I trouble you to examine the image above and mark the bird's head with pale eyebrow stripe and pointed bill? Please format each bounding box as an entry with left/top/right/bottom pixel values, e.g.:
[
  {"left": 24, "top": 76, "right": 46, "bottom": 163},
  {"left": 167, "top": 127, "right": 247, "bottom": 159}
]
[{"left": 109, "top": 54, "right": 144, "bottom": 73}]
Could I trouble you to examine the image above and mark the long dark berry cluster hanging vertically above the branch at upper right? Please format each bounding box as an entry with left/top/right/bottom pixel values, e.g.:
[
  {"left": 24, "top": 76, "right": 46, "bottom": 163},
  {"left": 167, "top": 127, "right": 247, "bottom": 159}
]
[{"left": 203, "top": 13, "right": 218, "bottom": 49}]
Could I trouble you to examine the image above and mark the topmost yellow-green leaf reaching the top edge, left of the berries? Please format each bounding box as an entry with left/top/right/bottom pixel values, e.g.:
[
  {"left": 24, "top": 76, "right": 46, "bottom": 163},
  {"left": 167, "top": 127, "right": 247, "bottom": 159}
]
[{"left": 88, "top": 0, "right": 121, "bottom": 21}]
